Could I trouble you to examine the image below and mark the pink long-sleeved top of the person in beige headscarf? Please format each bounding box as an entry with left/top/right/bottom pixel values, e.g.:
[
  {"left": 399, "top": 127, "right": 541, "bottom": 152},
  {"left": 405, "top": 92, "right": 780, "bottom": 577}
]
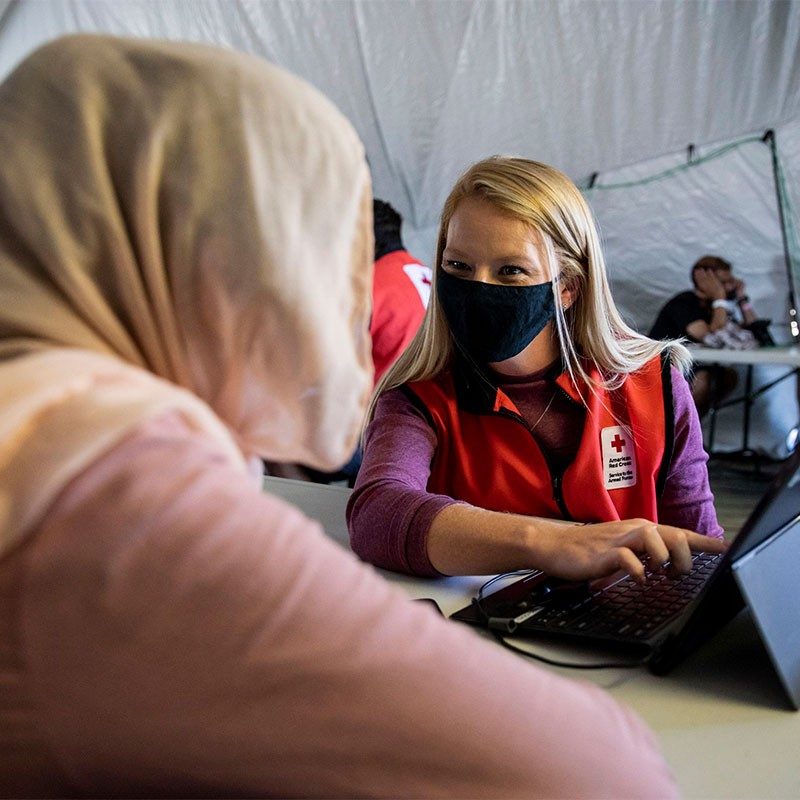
[{"left": 0, "top": 415, "right": 676, "bottom": 798}]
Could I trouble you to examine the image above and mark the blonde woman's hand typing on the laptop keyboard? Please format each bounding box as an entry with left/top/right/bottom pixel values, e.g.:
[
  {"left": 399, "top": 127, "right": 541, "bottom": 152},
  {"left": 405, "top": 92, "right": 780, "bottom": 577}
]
[{"left": 532, "top": 519, "right": 728, "bottom": 582}]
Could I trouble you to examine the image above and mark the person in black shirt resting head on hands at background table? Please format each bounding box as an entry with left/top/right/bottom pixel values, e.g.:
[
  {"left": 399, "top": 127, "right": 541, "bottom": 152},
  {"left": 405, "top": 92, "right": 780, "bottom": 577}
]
[{"left": 648, "top": 255, "right": 758, "bottom": 418}]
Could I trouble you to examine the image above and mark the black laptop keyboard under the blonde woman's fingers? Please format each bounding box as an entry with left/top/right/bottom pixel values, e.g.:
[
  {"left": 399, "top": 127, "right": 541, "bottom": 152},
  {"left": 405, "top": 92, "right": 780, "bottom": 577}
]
[{"left": 492, "top": 553, "right": 722, "bottom": 640}]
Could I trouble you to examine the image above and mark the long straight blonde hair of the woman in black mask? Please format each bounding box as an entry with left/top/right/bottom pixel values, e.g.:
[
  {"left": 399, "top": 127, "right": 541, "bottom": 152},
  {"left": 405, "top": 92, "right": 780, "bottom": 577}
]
[{"left": 366, "top": 156, "right": 691, "bottom": 422}]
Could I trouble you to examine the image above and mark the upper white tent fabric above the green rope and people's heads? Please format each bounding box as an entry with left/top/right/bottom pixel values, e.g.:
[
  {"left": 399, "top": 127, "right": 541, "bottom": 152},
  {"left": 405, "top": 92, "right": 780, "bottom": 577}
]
[{"left": 0, "top": 0, "right": 800, "bottom": 228}]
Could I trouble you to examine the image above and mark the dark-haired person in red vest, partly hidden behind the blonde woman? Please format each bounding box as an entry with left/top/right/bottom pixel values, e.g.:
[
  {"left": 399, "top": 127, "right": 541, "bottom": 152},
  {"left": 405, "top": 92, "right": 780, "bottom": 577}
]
[{"left": 369, "top": 199, "right": 431, "bottom": 383}]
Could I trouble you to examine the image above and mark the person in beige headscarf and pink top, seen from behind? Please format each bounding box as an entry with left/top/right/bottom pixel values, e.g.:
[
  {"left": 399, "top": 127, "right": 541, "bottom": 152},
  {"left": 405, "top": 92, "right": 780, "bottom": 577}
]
[{"left": 0, "top": 36, "right": 674, "bottom": 797}]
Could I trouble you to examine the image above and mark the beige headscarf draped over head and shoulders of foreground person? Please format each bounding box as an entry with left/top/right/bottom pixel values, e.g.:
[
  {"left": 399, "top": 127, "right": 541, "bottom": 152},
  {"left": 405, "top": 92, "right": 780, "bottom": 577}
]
[{"left": 0, "top": 36, "right": 373, "bottom": 552}]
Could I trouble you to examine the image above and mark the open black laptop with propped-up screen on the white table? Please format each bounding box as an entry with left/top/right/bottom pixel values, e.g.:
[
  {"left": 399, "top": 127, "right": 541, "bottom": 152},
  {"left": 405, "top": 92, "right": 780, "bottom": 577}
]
[{"left": 451, "top": 450, "right": 800, "bottom": 708}]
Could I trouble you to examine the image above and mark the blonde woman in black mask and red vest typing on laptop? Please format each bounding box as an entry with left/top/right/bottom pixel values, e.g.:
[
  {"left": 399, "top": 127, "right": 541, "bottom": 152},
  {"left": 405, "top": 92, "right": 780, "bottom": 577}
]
[{"left": 348, "top": 157, "right": 725, "bottom": 580}]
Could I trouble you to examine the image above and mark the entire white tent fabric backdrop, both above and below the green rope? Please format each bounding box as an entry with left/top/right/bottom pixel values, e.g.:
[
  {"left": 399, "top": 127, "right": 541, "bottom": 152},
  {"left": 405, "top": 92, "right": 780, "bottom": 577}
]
[{"left": 0, "top": 0, "right": 800, "bottom": 456}]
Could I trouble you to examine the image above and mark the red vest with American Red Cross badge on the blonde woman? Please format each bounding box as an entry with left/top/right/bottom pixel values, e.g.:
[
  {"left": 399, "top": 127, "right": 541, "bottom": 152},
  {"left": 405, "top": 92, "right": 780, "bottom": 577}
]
[{"left": 406, "top": 357, "right": 674, "bottom": 522}]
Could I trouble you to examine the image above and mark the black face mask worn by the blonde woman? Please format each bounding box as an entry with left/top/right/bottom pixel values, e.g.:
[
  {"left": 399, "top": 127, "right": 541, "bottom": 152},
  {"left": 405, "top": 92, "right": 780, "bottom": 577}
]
[{"left": 436, "top": 270, "right": 555, "bottom": 365}]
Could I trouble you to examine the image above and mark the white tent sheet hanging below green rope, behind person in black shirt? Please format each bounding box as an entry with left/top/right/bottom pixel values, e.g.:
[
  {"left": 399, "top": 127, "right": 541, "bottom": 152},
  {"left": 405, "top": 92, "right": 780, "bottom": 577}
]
[{"left": 586, "top": 123, "right": 800, "bottom": 457}]
